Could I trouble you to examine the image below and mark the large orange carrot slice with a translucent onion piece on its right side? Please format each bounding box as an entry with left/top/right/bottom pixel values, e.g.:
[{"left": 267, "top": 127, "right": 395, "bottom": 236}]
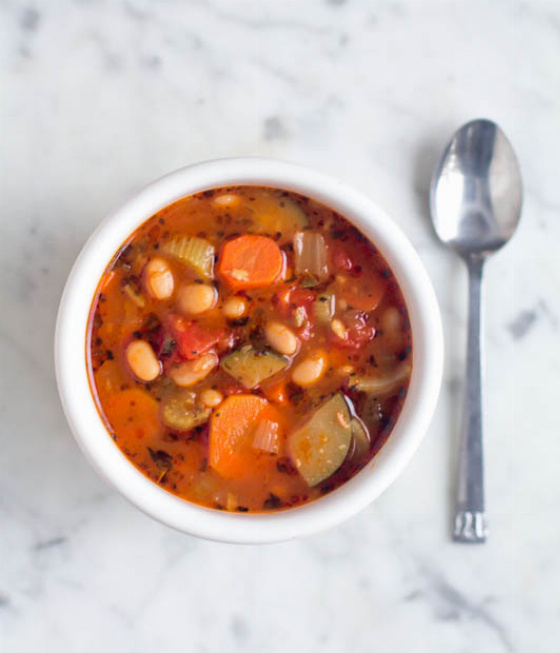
[{"left": 209, "top": 394, "right": 283, "bottom": 478}]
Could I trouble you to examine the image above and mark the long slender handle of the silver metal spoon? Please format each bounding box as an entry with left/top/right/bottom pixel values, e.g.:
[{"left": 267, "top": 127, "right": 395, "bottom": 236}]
[{"left": 453, "top": 256, "right": 488, "bottom": 543}]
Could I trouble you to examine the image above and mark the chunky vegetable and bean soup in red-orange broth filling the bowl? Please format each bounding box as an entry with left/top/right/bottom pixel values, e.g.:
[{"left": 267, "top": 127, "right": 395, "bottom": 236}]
[{"left": 86, "top": 186, "right": 412, "bottom": 512}]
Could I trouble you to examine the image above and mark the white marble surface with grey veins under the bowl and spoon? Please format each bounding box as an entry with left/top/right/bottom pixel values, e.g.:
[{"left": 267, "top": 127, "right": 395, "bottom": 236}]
[{"left": 0, "top": 0, "right": 560, "bottom": 653}]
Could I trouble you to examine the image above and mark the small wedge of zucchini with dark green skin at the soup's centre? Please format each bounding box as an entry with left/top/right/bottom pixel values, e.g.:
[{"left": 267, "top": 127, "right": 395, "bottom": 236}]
[{"left": 220, "top": 345, "right": 288, "bottom": 390}]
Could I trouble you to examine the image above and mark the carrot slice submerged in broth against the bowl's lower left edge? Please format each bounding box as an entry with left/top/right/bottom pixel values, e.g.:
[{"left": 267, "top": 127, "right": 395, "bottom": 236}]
[{"left": 103, "top": 388, "right": 161, "bottom": 443}]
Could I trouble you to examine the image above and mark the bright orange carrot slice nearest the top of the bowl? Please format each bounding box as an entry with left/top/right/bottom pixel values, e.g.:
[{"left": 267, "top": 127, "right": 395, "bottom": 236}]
[{"left": 218, "top": 235, "right": 284, "bottom": 290}]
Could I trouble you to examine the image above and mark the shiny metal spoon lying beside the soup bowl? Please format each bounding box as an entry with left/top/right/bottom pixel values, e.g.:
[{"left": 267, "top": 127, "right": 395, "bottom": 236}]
[{"left": 430, "top": 120, "right": 522, "bottom": 542}]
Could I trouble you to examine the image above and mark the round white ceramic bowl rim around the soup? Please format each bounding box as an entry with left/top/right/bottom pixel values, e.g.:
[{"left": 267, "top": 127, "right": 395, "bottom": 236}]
[{"left": 55, "top": 158, "right": 443, "bottom": 543}]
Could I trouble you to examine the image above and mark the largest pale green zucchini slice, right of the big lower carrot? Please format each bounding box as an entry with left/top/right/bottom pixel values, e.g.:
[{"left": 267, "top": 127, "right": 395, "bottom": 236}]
[{"left": 288, "top": 393, "right": 352, "bottom": 487}]
